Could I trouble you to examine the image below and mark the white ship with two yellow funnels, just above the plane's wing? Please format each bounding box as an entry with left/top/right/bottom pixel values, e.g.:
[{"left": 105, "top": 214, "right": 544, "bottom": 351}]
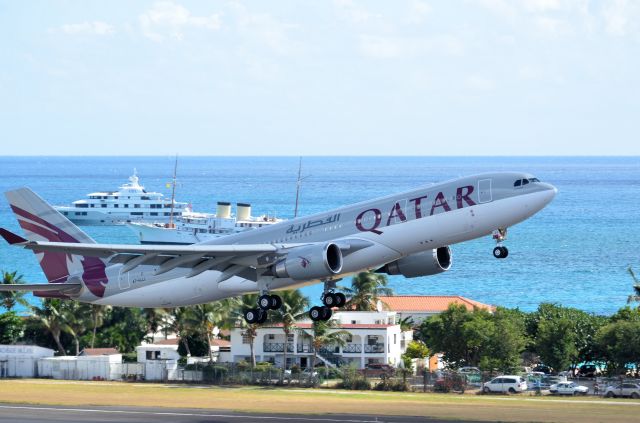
[{"left": 127, "top": 201, "right": 282, "bottom": 244}]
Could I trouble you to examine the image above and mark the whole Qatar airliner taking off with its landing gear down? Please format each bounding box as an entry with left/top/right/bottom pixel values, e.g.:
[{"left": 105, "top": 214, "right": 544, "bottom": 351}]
[{"left": 0, "top": 172, "right": 557, "bottom": 323}]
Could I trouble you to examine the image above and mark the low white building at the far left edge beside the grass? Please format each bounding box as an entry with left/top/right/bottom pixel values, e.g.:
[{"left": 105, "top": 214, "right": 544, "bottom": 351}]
[{"left": 0, "top": 345, "right": 54, "bottom": 378}]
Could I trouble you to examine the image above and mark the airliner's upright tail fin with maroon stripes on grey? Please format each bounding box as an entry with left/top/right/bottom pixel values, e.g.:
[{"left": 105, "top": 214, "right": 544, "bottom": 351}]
[{"left": 2, "top": 188, "right": 104, "bottom": 283}]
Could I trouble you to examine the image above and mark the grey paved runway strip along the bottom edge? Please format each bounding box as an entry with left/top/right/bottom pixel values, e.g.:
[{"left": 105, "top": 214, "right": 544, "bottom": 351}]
[{"left": 0, "top": 404, "right": 480, "bottom": 423}]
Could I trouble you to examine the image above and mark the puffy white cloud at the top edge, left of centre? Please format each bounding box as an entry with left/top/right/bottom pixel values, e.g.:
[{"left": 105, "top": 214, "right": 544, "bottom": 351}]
[{"left": 139, "top": 1, "right": 221, "bottom": 41}]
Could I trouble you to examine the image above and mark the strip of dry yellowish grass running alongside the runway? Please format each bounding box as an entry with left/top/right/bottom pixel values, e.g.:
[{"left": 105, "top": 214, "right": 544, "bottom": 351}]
[{"left": 0, "top": 379, "right": 640, "bottom": 423}]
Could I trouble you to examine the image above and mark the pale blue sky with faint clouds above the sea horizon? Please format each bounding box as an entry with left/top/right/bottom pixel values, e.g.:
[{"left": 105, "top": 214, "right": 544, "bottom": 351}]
[{"left": 0, "top": 0, "right": 640, "bottom": 156}]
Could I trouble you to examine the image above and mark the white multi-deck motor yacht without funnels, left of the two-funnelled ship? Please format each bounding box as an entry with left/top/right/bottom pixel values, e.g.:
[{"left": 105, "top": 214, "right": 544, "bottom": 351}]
[{"left": 55, "top": 169, "right": 188, "bottom": 225}]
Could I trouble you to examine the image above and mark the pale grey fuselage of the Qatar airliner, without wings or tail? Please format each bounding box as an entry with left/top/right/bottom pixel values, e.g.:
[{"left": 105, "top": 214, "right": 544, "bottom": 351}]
[{"left": 87, "top": 175, "right": 556, "bottom": 307}]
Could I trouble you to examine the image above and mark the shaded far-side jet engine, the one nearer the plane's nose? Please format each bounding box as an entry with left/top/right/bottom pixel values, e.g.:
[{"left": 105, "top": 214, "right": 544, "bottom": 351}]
[{"left": 376, "top": 247, "right": 452, "bottom": 278}]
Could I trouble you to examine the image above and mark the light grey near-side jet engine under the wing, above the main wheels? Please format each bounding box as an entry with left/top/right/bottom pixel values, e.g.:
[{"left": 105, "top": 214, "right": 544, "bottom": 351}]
[{"left": 272, "top": 242, "right": 342, "bottom": 281}]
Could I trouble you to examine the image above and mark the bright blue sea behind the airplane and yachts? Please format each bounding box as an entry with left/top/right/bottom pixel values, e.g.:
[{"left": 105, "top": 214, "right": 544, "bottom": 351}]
[{"left": 0, "top": 157, "right": 640, "bottom": 314}]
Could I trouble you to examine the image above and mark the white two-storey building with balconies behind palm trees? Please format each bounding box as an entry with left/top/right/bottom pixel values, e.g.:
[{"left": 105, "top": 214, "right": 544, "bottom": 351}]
[{"left": 231, "top": 311, "right": 412, "bottom": 368}]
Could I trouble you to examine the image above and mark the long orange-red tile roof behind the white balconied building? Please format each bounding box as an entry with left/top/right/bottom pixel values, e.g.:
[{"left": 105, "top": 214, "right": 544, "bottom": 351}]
[{"left": 378, "top": 295, "right": 495, "bottom": 313}]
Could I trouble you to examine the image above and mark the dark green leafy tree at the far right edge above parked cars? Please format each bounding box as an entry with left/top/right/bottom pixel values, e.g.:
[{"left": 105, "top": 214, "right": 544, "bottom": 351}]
[{"left": 596, "top": 320, "right": 640, "bottom": 375}]
